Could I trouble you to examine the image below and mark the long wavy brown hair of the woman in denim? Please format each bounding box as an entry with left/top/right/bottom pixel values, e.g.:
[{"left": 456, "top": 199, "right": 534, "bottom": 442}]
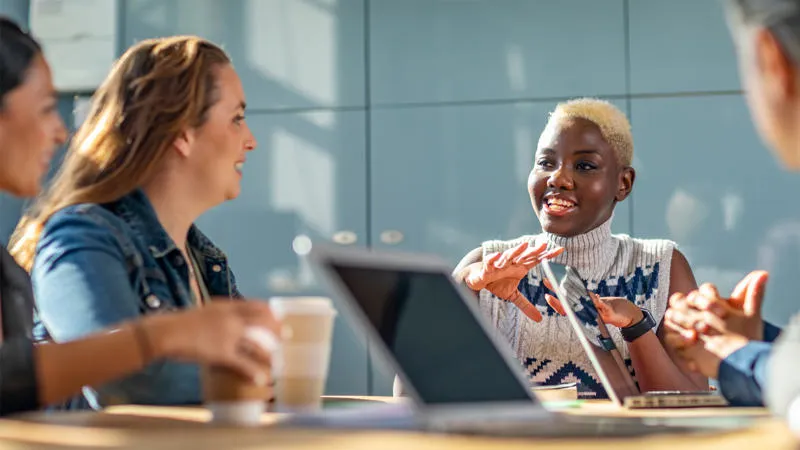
[{"left": 9, "top": 36, "right": 230, "bottom": 271}]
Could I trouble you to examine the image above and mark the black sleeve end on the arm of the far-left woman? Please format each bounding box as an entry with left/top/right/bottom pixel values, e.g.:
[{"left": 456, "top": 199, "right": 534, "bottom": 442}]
[{"left": 0, "top": 337, "right": 39, "bottom": 416}]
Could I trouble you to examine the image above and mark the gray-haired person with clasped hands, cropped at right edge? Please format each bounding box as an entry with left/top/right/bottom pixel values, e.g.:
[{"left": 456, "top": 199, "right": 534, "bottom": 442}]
[{"left": 666, "top": 0, "right": 800, "bottom": 422}]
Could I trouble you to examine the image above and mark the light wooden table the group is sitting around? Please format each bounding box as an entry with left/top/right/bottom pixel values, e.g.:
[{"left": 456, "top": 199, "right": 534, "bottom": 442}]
[{"left": 0, "top": 397, "right": 800, "bottom": 450}]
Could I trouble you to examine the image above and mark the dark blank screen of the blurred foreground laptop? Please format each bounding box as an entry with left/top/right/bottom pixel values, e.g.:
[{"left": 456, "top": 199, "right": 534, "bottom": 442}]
[{"left": 332, "top": 262, "right": 531, "bottom": 404}]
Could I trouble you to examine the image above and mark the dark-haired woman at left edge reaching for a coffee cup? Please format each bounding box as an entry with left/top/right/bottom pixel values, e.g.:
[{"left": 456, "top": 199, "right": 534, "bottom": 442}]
[{"left": 0, "top": 17, "right": 277, "bottom": 414}]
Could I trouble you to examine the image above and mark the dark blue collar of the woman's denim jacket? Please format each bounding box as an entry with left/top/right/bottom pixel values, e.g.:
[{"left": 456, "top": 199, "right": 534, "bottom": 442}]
[{"left": 110, "top": 189, "right": 226, "bottom": 261}]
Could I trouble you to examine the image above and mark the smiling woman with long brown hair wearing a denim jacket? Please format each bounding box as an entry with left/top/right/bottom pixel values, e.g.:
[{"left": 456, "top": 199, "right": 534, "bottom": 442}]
[{"left": 11, "top": 30, "right": 276, "bottom": 406}]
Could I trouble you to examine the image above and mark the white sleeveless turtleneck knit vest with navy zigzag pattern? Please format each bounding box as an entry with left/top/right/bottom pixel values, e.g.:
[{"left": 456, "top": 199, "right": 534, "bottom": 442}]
[{"left": 480, "top": 219, "right": 675, "bottom": 398}]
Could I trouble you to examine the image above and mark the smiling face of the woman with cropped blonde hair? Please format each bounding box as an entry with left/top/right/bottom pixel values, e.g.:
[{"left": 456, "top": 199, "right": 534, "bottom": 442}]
[{"left": 528, "top": 118, "right": 635, "bottom": 237}]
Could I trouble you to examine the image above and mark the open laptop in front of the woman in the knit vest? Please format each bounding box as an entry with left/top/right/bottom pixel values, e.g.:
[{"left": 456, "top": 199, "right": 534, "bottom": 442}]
[{"left": 541, "top": 260, "right": 728, "bottom": 408}]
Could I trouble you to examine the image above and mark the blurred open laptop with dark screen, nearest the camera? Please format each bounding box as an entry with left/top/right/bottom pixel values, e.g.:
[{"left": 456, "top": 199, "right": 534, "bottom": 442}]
[{"left": 309, "top": 244, "right": 748, "bottom": 437}]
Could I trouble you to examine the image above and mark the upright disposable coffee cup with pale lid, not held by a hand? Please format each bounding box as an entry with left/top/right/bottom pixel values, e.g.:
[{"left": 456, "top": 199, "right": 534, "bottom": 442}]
[{"left": 269, "top": 297, "right": 336, "bottom": 413}]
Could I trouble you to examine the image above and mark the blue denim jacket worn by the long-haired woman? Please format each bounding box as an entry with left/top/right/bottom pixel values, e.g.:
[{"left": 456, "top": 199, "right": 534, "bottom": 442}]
[{"left": 31, "top": 190, "right": 241, "bottom": 408}]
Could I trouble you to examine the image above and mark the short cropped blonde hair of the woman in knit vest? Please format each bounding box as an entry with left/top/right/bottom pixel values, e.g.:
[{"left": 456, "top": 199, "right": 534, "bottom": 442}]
[{"left": 547, "top": 98, "right": 633, "bottom": 166}]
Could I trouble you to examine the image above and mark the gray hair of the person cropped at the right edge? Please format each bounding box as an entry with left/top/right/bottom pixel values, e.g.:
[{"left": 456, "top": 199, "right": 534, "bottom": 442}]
[{"left": 725, "top": 0, "right": 800, "bottom": 64}]
